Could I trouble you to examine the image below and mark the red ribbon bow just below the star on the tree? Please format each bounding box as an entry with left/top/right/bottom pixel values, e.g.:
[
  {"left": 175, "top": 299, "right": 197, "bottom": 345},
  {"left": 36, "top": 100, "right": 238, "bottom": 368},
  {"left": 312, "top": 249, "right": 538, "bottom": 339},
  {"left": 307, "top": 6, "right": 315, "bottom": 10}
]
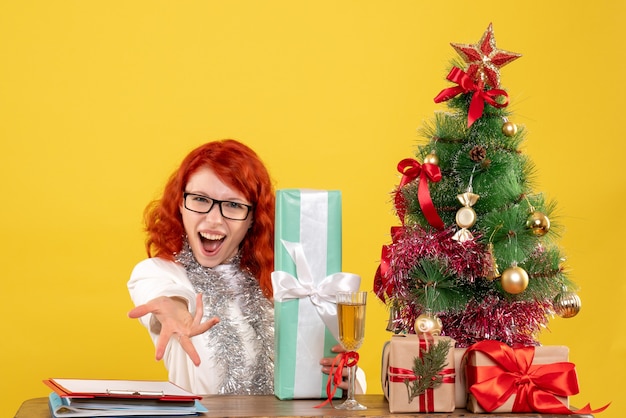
[{"left": 435, "top": 67, "right": 509, "bottom": 128}]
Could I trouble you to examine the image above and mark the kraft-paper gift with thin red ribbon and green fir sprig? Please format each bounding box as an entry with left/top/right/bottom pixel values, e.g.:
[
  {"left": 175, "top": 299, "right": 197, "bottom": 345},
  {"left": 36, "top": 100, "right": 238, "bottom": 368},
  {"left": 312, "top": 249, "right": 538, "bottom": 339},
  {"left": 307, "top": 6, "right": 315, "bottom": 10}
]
[{"left": 381, "top": 334, "right": 455, "bottom": 413}]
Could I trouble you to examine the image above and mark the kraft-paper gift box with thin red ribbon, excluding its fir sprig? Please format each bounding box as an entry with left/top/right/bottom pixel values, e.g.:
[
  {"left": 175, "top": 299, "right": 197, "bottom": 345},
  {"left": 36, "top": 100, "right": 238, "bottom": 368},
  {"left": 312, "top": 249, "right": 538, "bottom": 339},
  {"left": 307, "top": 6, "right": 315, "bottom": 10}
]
[{"left": 381, "top": 334, "right": 456, "bottom": 413}]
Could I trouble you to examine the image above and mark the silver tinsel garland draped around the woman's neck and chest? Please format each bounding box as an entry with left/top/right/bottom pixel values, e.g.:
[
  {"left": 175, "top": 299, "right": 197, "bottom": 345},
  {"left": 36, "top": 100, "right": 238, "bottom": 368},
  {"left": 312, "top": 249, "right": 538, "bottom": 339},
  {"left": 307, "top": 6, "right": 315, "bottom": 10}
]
[{"left": 176, "top": 243, "right": 274, "bottom": 395}]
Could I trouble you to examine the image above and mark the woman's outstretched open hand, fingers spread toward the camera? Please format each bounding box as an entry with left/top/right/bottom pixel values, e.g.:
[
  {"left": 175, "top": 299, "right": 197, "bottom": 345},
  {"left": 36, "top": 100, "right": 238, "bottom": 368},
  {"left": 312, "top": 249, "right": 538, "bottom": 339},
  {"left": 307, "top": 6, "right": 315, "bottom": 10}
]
[{"left": 128, "top": 293, "right": 220, "bottom": 366}]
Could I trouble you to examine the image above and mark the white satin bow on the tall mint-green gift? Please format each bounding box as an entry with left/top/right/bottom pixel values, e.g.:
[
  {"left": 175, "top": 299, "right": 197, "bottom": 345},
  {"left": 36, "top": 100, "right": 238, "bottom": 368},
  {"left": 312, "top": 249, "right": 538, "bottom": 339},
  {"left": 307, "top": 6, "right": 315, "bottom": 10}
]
[{"left": 272, "top": 240, "right": 361, "bottom": 341}]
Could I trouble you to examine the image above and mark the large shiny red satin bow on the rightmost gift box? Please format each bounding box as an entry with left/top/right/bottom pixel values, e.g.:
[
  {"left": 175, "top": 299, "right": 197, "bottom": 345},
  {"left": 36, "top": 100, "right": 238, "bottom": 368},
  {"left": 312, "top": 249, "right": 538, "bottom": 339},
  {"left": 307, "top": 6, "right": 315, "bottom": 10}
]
[{"left": 465, "top": 340, "right": 609, "bottom": 414}]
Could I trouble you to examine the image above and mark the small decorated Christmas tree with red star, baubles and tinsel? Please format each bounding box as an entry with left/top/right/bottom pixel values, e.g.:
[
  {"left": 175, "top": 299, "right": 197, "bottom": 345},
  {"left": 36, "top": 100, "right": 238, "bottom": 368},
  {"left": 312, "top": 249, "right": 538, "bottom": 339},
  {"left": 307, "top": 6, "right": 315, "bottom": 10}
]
[{"left": 374, "top": 24, "right": 580, "bottom": 347}]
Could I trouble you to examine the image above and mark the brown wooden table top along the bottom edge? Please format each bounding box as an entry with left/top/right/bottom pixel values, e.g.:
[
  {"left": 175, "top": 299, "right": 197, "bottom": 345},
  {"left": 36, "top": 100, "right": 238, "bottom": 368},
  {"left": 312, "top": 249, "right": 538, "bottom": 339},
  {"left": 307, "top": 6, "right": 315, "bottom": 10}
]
[{"left": 15, "top": 395, "right": 592, "bottom": 418}]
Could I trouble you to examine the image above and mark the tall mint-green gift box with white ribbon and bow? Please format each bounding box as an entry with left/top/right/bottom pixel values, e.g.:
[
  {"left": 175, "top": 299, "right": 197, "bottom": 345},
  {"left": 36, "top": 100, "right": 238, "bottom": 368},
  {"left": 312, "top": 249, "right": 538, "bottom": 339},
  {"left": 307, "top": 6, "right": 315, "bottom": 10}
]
[{"left": 272, "top": 189, "right": 361, "bottom": 399}]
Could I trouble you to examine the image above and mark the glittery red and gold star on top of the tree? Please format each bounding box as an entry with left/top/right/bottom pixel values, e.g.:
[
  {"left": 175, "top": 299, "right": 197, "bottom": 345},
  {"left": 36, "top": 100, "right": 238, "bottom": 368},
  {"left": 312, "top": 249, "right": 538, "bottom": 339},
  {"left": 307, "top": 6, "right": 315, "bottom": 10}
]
[{"left": 450, "top": 23, "right": 522, "bottom": 88}]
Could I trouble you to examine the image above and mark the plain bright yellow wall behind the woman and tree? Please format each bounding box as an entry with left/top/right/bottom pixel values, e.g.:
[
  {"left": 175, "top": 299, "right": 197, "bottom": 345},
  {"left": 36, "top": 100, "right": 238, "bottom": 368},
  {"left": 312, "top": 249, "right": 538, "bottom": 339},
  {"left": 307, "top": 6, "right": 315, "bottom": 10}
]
[{"left": 0, "top": 0, "right": 626, "bottom": 418}]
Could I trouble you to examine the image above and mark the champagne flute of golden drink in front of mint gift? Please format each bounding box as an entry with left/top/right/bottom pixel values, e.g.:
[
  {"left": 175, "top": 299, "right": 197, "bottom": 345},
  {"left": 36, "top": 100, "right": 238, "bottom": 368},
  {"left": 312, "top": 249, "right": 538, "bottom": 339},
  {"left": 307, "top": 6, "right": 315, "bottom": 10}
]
[{"left": 335, "top": 292, "right": 367, "bottom": 411}]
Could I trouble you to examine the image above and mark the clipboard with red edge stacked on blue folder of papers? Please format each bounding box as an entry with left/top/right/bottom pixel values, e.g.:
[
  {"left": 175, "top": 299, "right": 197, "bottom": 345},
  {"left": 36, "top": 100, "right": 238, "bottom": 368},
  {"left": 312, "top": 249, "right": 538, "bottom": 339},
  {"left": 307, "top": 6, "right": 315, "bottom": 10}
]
[{"left": 44, "top": 379, "right": 207, "bottom": 418}]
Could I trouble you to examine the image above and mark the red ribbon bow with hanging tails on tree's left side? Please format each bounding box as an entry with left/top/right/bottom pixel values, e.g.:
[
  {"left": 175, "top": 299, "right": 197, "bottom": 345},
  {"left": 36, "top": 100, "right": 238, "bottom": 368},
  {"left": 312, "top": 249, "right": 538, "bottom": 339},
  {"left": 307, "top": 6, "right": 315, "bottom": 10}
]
[{"left": 395, "top": 158, "right": 444, "bottom": 230}]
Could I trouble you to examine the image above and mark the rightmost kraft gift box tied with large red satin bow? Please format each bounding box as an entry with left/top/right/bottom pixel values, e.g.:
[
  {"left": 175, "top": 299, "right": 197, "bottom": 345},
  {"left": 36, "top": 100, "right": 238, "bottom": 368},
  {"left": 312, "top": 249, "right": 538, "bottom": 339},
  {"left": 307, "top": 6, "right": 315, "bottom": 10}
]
[{"left": 464, "top": 340, "right": 608, "bottom": 415}]
